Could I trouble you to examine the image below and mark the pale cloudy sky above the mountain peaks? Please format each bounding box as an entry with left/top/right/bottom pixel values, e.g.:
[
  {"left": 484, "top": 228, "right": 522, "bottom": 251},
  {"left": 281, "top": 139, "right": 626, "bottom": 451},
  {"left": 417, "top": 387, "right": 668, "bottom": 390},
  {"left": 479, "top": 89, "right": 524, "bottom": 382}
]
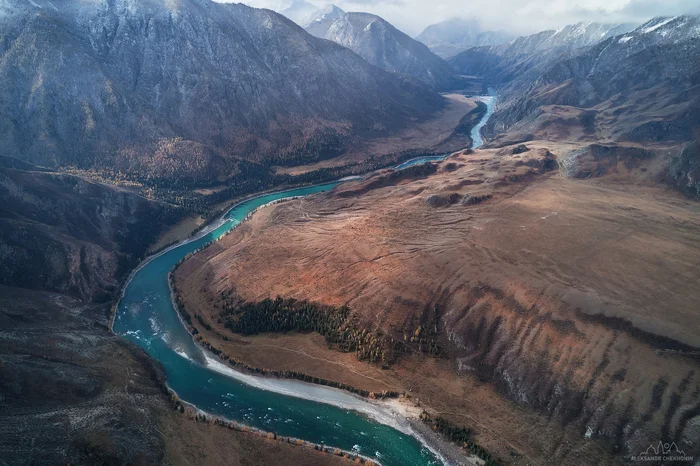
[{"left": 238, "top": 0, "right": 700, "bottom": 36}]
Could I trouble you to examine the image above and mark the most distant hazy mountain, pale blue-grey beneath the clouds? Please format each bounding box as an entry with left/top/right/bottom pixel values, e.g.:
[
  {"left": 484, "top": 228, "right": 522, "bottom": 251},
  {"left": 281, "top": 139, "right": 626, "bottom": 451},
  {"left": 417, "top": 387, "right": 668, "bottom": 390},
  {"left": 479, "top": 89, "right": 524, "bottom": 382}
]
[{"left": 416, "top": 18, "right": 513, "bottom": 58}]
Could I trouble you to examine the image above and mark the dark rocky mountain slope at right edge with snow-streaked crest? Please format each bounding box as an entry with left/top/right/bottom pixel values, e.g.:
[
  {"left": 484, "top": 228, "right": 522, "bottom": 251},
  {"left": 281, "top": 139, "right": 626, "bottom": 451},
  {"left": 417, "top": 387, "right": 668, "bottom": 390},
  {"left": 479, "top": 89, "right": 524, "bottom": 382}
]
[{"left": 487, "top": 16, "right": 700, "bottom": 143}]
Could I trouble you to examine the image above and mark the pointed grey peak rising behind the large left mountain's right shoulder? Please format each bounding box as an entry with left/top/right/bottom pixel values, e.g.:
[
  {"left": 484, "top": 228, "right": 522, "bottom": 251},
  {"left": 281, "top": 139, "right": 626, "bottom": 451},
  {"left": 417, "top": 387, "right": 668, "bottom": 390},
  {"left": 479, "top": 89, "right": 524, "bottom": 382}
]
[{"left": 306, "top": 10, "right": 462, "bottom": 90}]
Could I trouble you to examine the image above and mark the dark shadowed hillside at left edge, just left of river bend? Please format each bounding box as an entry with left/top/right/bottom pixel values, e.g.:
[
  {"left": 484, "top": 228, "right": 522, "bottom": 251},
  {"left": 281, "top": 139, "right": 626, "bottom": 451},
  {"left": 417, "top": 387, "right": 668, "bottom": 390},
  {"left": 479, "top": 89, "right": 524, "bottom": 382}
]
[{"left": 0, "top": 160, "right": 181, "bottom": 301}]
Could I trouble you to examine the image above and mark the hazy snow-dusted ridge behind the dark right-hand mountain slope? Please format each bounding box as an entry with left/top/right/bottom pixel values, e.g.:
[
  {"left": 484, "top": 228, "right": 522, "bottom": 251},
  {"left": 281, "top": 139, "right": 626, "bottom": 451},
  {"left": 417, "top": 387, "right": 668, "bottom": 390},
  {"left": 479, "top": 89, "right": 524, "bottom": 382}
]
[{"left": 449, "top": 23, "right": 634, "bottom": 85}]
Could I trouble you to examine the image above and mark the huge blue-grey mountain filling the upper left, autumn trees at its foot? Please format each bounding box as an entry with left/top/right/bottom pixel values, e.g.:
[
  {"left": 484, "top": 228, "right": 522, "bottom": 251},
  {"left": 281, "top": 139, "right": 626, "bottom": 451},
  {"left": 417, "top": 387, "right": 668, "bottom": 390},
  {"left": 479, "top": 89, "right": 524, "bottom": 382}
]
[{"left": 0, "top": 0, "right": 443, "bottom": 184}]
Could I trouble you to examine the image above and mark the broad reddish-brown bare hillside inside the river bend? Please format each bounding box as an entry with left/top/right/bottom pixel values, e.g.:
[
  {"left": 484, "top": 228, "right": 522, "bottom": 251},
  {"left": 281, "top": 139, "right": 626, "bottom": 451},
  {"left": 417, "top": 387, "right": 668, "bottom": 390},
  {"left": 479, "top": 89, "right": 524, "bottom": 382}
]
[{"left": 176, "top": 141, "right": 700, "bottom": 464}]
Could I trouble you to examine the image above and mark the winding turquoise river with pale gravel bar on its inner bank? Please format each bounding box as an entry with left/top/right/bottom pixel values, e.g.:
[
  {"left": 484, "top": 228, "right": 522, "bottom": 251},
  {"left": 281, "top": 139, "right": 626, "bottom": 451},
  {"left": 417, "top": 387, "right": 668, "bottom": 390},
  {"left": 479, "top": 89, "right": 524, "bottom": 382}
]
[{"left": 113, "top": 92, "right": 495, "bottom": 466}]
